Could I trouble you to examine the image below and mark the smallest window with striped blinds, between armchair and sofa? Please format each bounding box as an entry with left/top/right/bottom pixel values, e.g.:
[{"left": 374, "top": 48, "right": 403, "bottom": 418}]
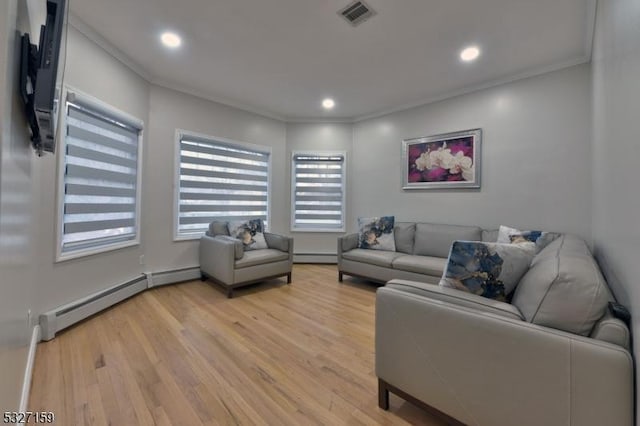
[{"left": 291, "top": 152, "right": 346, "bottom": 232}]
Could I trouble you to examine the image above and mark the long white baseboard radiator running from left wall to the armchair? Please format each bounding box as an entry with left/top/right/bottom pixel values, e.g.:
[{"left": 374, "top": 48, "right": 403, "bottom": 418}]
[{"left": 40, "top": 267, "right": 200, "bottom": 340}]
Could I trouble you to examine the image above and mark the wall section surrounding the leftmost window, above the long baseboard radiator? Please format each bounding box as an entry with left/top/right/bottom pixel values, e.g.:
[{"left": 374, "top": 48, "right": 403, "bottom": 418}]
[{"left": 34, "top": 25, "right": 150, "bottom": 312}]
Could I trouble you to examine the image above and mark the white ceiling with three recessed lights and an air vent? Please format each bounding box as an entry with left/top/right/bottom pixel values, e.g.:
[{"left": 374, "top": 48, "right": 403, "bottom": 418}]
[{"left": 70, "top": 0, "right": 595, "bottom": 121}]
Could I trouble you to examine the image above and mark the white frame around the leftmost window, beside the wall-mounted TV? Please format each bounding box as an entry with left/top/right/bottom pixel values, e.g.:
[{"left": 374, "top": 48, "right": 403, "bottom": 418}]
[{"left": 55, "top": 85, "right": 144, "bottom": 262}]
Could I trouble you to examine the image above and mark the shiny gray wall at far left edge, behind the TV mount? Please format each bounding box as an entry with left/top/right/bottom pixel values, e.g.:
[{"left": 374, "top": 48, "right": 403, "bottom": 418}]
[{"left": 0, "top": 0, "right": 39, "bottom": 412}]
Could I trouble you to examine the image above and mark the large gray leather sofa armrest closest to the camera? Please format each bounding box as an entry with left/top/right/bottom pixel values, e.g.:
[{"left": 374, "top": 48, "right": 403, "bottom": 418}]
[{"left": 375, "top": 287, "right": 634, "bottom": 426}]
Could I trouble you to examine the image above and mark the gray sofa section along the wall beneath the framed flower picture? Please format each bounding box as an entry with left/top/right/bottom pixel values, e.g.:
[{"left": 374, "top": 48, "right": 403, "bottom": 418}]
[{"left": 338, "top": 222, "right": 498, "bottom": 284}]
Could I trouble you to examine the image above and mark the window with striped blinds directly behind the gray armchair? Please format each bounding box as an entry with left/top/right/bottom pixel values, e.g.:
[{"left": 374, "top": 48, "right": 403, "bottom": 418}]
[{"left": 176, "top": 133, "right": 270, "bottom": 239}]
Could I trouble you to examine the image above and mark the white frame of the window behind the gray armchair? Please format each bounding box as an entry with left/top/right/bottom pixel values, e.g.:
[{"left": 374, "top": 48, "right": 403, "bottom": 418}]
[{"left": 173, "top": 129, "right": 273, "bottom": 241}]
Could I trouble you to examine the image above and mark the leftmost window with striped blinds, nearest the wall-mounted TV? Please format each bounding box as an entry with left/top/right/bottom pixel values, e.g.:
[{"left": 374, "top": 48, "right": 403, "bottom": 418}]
[{"left": 58, "top": 91, "right": 142, "bottom": 260}]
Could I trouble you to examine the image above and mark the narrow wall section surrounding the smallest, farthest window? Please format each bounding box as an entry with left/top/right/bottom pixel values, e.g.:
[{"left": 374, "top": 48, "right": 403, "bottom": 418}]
[{"left": 286, "top": 123, "right": 353, "bottom": 254}]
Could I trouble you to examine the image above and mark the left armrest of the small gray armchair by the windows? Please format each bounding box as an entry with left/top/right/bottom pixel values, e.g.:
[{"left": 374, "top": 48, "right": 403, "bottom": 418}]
[{"left": 199, "top": 235, "right": 236, "bottom": 284}]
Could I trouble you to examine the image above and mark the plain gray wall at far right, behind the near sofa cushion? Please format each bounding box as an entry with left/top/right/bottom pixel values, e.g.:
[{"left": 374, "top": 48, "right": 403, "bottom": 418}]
[{"left": 592, "top": 0, "right": 640, "bottom": 416}]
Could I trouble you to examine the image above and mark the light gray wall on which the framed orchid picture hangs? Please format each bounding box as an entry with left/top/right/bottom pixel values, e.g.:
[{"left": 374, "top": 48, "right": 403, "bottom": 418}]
[{"left": 348, "top": 65, "right": 591, "bottom": 240}]
